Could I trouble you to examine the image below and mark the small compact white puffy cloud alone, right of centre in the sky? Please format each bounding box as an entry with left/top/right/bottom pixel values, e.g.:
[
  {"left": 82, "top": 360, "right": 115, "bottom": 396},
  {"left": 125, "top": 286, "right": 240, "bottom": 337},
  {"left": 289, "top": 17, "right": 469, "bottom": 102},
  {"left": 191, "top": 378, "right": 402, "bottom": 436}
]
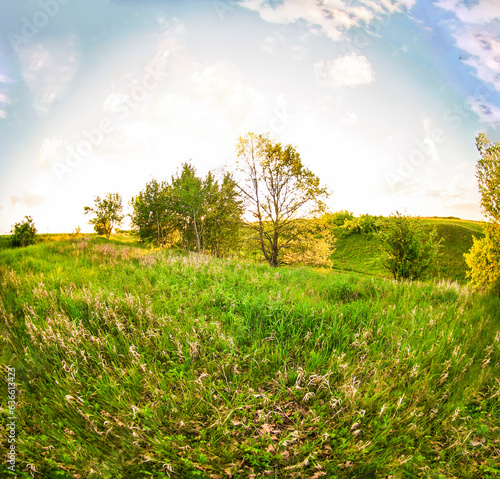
[{"left": 314, "top": 53, "right": 375, "bottom": 88}]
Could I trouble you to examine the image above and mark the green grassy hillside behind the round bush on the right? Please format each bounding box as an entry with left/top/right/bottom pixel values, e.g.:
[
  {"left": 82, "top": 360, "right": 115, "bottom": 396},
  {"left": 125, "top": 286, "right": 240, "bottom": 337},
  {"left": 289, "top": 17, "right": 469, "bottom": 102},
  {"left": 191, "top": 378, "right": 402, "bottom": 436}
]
[{"left": 333, "top": 218, "right": 483, "bottom": 283}]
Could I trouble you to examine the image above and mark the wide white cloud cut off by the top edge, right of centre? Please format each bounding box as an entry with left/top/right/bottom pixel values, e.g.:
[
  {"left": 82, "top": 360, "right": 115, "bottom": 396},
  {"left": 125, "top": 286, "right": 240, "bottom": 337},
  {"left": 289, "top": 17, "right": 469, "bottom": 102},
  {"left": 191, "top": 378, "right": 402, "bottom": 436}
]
[{"left": 239, "top": 0, "right": 415, "bottom": 41}]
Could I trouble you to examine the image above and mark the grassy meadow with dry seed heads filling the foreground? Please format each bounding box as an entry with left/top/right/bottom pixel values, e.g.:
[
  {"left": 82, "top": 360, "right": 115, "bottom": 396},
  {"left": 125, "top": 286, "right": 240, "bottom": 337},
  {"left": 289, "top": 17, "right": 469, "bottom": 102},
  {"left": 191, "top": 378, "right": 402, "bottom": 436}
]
[{"left": 0, "top": 238, "right": 500, "bottom": 479}]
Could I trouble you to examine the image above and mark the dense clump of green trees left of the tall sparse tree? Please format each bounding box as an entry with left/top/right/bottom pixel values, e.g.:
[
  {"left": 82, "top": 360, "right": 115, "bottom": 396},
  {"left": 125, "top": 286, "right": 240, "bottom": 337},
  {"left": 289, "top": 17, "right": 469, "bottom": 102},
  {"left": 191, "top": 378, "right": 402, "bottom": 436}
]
[{"left": 132, "top": 163, "right": 243, "bottom": 257}]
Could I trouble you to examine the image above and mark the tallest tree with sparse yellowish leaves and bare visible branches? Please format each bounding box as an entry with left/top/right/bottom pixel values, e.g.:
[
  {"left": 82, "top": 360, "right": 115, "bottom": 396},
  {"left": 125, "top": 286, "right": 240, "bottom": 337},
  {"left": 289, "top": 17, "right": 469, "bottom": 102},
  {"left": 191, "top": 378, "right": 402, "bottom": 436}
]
[{"left": 237, "top": 133, "right": 328, "bottom": 267}]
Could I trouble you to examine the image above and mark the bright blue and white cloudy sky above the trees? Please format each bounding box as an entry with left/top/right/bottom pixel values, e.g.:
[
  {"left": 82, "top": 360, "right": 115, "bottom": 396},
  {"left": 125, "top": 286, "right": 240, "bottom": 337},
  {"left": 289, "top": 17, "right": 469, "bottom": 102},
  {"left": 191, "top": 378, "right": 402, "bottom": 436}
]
[{"left": 0, "top": 0, "right": 500, "bottom": 234}]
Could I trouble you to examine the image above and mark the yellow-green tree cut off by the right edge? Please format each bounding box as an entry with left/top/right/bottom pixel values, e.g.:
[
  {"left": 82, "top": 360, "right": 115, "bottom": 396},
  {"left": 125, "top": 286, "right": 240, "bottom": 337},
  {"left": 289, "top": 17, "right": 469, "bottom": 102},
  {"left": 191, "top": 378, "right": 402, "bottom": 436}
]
[{"left": 465, "top": 133, "right": 500, "bottom": 296}]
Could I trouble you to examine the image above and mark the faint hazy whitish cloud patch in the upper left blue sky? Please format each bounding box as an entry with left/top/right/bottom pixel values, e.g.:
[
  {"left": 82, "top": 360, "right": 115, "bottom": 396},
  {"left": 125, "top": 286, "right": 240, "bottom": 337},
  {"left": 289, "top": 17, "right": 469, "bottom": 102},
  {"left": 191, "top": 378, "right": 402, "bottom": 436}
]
[{"left": 18, "top": 39, "right": 78, "bottom": 113}]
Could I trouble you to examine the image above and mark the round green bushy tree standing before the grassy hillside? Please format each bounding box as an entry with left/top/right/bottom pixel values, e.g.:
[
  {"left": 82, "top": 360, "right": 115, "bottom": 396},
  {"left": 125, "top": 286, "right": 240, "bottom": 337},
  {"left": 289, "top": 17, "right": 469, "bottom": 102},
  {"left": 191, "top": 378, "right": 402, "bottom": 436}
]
[{"left": 379, "top": 212, "right": 442, "bottom": 280}]
